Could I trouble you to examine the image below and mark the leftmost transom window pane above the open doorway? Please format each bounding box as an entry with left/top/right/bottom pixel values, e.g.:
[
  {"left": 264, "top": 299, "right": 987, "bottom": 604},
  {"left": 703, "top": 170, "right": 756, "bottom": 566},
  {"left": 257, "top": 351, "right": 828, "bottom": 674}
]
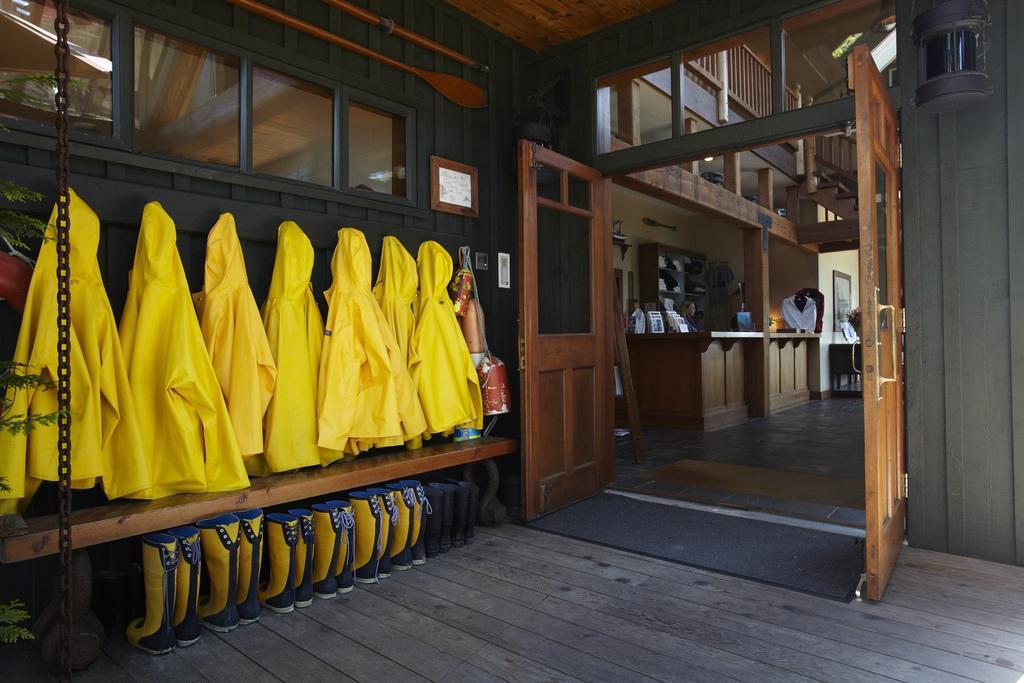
[{"left": 597, "top": 59, "right": 672, "bottom": 152}]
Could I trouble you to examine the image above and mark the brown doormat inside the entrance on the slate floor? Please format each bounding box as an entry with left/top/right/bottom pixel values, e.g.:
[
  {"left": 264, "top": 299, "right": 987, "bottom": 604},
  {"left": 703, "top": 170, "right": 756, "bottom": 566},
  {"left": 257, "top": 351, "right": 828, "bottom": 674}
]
[{"left": 637, "top": 460, "right": 864, "bottom": 510}]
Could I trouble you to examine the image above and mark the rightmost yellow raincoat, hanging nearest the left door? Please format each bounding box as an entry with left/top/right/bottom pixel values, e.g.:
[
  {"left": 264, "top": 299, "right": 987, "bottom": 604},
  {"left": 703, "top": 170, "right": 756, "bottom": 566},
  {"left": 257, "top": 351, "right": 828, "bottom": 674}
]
[{"left": 410, "top": 242, "right": 483, "bottom": 434}]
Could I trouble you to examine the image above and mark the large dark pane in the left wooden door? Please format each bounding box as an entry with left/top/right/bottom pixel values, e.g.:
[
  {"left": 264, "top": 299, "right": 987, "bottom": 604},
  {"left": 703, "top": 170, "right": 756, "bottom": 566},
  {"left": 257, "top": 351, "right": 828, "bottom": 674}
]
[{"left": 537, "top": 206, "right": 591, "bottom": 335}]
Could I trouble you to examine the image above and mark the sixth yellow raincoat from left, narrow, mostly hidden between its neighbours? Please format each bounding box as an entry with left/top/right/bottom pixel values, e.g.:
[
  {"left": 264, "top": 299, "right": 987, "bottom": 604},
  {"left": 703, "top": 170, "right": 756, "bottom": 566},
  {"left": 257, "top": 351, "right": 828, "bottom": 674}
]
[{"left": 374, "top": 236, "right": 430, "bottom": 449}]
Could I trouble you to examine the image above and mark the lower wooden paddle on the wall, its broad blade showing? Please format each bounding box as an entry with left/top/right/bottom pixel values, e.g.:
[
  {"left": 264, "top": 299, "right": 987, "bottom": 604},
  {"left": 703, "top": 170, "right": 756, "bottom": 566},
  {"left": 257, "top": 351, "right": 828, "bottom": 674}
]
[{"left": 227, "top": 0, "right": 487, "bottom": 109}]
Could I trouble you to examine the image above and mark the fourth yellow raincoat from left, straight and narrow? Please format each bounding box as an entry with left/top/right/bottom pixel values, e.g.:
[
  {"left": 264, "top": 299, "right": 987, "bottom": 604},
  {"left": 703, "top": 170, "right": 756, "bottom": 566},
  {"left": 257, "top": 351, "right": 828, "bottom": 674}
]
[{"left": 256, "top": 220, "right": 324, "bottom": 474}]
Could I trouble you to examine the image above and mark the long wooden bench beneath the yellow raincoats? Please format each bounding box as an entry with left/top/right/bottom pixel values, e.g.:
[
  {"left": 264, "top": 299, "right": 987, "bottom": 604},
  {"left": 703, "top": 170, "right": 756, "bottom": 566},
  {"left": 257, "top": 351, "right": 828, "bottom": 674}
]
[{"left": 0, "top": 437, "right": 519, "bottom": 564}]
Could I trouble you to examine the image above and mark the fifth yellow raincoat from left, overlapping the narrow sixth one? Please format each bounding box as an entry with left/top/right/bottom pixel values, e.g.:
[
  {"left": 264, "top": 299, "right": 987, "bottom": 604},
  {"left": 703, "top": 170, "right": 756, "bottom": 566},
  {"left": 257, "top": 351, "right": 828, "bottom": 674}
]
[{"left": 317, "top": 227, "right": 423, "bottom": 464}]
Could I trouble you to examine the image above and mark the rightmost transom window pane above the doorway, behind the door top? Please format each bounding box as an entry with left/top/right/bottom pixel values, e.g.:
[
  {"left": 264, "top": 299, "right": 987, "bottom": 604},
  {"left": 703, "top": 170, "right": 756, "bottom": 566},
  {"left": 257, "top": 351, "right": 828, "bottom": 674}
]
[{"left": 782, "top": 0, "right": 896, "bottom": 110}]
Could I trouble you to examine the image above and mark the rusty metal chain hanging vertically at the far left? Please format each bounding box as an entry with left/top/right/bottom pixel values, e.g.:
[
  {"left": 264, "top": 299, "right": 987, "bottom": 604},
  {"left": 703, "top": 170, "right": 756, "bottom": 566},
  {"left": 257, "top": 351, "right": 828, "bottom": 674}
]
[{"left": 53, "top": 0, "right": 73, "bottom": 681}]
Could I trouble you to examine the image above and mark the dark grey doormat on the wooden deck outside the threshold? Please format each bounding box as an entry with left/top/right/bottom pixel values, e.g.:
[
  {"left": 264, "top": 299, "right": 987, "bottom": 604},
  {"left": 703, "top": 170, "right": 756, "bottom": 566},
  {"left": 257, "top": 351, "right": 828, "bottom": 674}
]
[{"left": 528, "top": 494, "right": 864, "bottom": 602}]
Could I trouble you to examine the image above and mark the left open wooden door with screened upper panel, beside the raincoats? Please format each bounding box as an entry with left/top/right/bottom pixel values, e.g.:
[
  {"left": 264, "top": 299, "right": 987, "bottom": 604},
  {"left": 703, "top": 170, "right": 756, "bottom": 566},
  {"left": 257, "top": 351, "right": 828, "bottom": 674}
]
[{"left": 517, "top": 140, "right": 614, "bottom": 519}]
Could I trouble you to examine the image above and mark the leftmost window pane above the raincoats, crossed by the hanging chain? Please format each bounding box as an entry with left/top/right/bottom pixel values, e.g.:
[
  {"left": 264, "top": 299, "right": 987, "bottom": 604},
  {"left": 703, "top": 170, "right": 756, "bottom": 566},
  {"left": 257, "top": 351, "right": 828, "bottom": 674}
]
[{"left": 0, "top": 0, "right": 113, "bottom": 135}]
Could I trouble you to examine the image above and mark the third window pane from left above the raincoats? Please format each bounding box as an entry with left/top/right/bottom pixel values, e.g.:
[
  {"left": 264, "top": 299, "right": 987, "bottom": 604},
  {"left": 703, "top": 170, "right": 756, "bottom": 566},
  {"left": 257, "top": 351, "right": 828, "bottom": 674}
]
[{"left": 253, "top": 67, "right": 334, "bottom": 185}]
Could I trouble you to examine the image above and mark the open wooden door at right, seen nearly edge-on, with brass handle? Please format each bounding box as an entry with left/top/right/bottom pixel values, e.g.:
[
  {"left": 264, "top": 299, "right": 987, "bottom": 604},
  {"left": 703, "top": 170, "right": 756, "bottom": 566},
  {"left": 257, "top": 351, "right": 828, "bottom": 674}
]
[{"left": 850, "top": 45, "right": 906, "bottom": 600}]
